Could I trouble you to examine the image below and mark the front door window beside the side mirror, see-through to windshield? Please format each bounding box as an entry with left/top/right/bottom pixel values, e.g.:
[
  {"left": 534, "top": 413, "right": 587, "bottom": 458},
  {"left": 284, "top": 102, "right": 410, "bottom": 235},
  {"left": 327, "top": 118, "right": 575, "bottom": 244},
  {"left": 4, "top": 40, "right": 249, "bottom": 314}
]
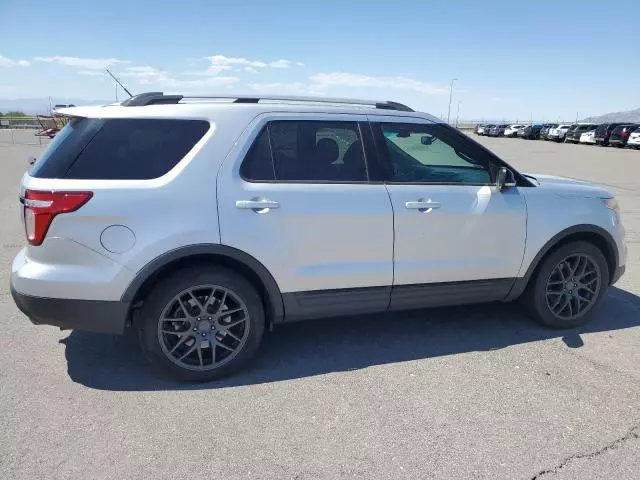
[{"left": 379, "top": 123, "right": 492, "bottom": 185}]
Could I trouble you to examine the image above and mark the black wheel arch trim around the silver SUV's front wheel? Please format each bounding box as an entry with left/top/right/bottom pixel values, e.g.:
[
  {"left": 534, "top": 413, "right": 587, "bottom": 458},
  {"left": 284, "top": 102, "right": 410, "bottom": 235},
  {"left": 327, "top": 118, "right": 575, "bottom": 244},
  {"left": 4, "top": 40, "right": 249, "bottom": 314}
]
[{"left": 505, "top": 224, "right": 618, "bottom": 301}]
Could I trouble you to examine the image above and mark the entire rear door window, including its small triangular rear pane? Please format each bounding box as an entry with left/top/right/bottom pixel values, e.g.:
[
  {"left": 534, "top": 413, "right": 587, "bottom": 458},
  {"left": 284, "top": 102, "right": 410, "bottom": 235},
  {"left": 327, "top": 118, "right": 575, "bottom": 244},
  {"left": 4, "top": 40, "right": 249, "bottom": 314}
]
[{"left": 240, "top": 120, "right": 367, "bottom": 182}]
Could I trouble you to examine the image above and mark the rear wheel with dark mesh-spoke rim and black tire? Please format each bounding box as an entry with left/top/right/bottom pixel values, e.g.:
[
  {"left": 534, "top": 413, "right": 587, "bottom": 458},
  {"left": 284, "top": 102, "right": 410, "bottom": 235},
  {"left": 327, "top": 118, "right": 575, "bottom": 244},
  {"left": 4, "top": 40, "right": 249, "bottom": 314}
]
[{"left": 139, "top": 266, "right": 265, "bottom": 382}]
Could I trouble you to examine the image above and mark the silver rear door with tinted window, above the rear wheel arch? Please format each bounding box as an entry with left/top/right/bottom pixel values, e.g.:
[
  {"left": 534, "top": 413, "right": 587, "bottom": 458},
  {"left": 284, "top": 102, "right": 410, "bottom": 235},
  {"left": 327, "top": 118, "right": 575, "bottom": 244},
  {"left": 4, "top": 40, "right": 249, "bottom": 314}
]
[{"left": 217, "top": 113, "right": 393, "bottom": 320}]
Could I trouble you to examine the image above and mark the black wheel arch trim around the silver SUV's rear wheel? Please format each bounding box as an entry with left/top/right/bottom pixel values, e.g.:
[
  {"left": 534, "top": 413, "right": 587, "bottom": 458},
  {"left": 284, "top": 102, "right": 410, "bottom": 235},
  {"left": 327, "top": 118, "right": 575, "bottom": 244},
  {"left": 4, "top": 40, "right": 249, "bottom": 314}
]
[{"left": 121, "top": 244, "right": 284, "bottom": 324}]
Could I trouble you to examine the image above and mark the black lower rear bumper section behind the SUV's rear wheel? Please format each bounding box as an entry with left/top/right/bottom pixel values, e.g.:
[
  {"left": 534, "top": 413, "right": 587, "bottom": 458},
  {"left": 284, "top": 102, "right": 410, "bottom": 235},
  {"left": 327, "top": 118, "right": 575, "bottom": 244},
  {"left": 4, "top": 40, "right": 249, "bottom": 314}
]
[{"left": 11, "top": 283, "right": 129, "bottom": 334}]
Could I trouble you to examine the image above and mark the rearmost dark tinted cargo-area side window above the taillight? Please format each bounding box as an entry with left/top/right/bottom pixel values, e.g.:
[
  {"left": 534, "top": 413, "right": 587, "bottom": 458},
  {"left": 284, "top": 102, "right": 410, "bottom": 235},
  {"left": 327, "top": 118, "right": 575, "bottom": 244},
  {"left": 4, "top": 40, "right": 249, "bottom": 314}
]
[{"left": 30, "top": 118, "right": 209, "bottom": 180}]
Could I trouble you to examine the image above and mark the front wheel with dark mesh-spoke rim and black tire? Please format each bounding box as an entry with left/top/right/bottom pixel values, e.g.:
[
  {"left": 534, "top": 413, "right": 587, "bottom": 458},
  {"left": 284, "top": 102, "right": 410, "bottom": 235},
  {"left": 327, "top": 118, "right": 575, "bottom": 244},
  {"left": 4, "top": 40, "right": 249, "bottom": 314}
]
[{"left": 522, "top": 241, "right": 610, "bottom": 329}]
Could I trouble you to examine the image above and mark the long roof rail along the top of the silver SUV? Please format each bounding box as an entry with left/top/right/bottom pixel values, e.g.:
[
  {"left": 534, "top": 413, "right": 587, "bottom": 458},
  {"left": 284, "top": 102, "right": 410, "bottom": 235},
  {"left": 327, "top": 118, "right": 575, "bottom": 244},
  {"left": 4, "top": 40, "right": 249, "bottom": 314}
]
[{"left": 121, "top": 92, "right": 413, "bottom": 112}]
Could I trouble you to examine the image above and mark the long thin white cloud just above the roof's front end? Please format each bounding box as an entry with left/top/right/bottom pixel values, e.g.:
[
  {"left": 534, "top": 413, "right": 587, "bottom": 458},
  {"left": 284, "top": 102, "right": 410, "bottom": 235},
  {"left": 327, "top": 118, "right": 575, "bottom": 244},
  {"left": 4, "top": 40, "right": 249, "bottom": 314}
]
[{"left": 310, "top": 72, "right": 449, "bottom": 95}]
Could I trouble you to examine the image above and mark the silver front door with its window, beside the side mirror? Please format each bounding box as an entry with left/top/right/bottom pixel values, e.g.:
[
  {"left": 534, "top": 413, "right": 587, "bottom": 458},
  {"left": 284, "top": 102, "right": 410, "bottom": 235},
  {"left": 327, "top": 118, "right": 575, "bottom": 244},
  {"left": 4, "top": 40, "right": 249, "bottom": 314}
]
[{"left": 370, "top": 116, "right": 526, "bottom": 309}]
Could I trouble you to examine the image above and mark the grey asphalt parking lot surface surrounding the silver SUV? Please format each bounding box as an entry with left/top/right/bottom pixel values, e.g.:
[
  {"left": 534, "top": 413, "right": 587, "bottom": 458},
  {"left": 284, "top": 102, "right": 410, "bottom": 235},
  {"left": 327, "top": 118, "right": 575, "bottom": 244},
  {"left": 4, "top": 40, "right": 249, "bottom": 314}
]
[{"left": 0, "top": 137, "right": 640, "bottom": 480}]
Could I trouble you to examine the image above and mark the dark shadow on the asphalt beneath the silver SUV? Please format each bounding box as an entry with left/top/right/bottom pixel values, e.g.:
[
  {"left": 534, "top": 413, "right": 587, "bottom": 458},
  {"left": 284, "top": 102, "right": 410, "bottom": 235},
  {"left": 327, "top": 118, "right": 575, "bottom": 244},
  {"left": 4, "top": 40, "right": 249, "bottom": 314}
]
[{"left": 60, "top": 287, "right": 640, "bottom": 391}]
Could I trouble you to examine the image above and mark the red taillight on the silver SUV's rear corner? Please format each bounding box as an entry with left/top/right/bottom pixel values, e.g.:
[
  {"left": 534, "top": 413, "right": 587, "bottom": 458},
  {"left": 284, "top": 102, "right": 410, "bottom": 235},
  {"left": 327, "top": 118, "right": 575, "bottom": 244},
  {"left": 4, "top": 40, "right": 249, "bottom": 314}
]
[{"left": 24, "top": 190, "right": 93, "bottom": 246}]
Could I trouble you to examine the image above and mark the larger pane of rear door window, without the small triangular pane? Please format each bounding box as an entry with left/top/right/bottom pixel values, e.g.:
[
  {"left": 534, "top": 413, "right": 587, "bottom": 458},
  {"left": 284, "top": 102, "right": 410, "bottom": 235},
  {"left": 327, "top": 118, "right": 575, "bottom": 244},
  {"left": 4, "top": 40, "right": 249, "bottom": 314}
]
[{"left": 268, "top": 120, "right": 367, "bottom": 182}]
